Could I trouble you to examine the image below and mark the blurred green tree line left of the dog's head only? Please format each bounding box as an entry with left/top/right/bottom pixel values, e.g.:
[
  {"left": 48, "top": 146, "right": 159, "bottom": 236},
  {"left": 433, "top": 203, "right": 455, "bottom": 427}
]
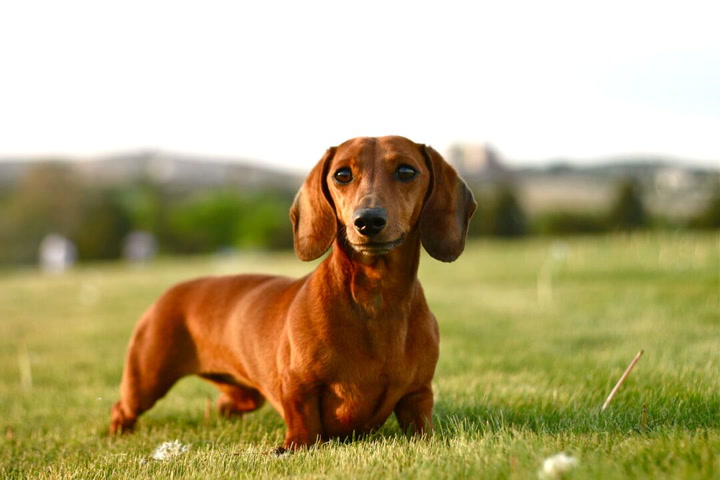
[{"left": 0, "top": 163, "right": 294, "bottom": 264}]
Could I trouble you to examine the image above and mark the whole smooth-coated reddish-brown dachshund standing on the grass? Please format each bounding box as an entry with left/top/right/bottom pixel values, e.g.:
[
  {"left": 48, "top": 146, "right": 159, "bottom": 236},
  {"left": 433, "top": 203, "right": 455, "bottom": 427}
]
[{"left": 110, "top": 137, "right": 476, "bottom": 450}]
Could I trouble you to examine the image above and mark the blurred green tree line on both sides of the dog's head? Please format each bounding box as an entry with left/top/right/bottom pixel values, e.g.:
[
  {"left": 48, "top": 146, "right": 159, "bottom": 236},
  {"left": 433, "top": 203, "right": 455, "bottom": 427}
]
[{"left": 0, "top": 163, "right": 720, "bottom": 265}]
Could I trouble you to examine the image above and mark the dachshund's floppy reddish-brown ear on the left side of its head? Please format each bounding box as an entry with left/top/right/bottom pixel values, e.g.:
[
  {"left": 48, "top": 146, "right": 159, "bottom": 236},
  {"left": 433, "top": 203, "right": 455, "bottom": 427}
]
[{"left": 290, "top": 147, "right": 337, "bottom": 262}]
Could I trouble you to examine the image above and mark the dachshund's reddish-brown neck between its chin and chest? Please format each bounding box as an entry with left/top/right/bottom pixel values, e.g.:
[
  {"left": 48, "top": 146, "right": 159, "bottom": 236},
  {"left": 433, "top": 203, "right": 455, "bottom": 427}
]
[{"left": 327, "top": 232, "right": 420, "bottom": 316}]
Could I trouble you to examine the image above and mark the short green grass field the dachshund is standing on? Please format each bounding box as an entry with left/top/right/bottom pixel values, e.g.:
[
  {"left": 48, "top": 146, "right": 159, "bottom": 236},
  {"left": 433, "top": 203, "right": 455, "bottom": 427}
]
[{"left": 0, "top": 234, "right": 720, "bottom": 479}]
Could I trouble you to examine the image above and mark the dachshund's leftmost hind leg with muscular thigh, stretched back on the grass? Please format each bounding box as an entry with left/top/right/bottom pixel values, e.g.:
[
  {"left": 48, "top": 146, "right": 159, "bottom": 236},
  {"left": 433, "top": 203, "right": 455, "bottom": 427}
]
[{"left": 110, "top": 314, "right": 197, "bottom": 433}]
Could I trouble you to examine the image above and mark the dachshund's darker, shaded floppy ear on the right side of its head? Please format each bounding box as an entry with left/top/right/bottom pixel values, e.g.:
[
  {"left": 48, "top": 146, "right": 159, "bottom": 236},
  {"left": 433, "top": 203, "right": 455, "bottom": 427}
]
[{"left": 420, "top": 145, "right": 477, "bottom": 262}]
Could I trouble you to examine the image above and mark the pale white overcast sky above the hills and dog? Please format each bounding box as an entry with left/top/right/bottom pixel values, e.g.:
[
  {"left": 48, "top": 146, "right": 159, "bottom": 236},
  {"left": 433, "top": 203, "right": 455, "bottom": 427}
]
[{"left": 0, "top": 0, "right": 720, "bottom": 170}]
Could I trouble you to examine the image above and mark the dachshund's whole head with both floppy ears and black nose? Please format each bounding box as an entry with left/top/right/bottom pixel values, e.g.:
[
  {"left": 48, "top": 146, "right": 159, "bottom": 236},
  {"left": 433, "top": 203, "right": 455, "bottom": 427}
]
[{"left": 290, "top": 136, "right": 477, "bottom": 262}]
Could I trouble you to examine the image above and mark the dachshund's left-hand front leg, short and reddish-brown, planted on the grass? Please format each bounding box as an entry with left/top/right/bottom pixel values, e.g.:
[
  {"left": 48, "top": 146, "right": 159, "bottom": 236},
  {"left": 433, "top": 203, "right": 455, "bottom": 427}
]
[{"left": 278, "top": 385, "right": 323, "bottom": 452}]
